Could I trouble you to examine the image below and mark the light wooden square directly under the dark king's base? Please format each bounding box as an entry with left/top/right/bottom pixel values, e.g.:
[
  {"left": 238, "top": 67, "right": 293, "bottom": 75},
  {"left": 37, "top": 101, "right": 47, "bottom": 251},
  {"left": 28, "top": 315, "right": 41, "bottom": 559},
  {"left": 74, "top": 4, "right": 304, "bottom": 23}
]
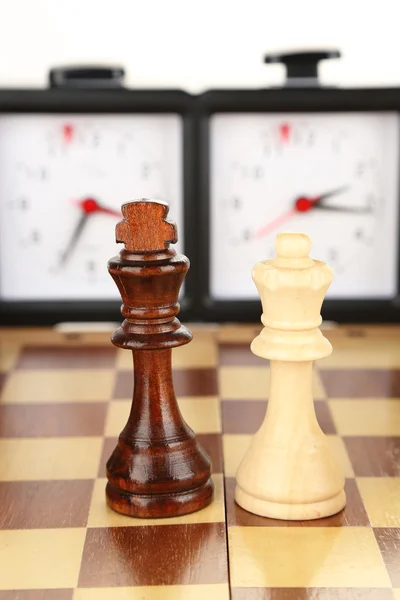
[{"left": 88, "top": 473, "right": 225, "bottom": 527}]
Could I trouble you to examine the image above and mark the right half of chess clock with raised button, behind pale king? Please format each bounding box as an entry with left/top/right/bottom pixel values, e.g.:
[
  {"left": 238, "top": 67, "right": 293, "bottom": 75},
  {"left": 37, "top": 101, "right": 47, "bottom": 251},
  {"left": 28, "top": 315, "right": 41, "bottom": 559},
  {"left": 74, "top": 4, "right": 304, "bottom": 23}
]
[{"left": 199, "top": 51, "right": 400, "bottom": 322}]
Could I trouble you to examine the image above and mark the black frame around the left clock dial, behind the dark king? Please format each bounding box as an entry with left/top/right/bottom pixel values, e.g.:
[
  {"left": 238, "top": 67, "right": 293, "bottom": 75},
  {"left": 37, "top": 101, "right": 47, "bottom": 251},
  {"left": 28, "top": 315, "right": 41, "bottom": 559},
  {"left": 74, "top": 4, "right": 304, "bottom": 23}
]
[{"left": 0, "top": 87, "right": 198, "bottom": 326}]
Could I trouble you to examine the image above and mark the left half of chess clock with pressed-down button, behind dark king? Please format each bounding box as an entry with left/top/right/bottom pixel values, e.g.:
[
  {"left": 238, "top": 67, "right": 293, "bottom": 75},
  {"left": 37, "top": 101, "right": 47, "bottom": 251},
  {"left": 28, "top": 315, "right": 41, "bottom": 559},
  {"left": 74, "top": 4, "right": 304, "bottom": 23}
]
[{"left": 0, "top": 67, "right": 195, "bottom": 325}]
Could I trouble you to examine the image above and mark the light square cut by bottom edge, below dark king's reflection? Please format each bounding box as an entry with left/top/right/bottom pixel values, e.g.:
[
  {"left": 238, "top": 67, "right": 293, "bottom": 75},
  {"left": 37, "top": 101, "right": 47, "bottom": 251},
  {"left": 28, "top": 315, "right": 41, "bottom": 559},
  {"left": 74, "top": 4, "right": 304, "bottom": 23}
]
[{"left": 73, "top": 583, "right": 229, "bottom": 600}]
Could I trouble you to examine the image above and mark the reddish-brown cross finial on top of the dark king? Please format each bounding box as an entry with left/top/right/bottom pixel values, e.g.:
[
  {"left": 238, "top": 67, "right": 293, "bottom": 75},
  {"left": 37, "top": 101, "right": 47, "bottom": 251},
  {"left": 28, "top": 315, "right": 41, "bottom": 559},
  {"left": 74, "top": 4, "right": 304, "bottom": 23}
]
[{"left": 115, "top": 198, "right": 178, "bottom": 252}]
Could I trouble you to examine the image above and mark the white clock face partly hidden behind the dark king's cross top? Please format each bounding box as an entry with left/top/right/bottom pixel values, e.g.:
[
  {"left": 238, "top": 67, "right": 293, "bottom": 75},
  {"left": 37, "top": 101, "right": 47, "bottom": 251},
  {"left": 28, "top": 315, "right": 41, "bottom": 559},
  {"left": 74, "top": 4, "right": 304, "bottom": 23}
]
[{"left": 0, "top": 114, "right": 183, "bottom": 301}]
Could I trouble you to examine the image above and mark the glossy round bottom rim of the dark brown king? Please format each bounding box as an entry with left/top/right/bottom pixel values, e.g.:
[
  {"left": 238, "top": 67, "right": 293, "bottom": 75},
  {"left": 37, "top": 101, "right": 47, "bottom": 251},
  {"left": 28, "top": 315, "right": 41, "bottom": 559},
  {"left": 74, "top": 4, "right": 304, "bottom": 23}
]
[{"left": 106, "top": 477, "right": 214, "bottom": 519}]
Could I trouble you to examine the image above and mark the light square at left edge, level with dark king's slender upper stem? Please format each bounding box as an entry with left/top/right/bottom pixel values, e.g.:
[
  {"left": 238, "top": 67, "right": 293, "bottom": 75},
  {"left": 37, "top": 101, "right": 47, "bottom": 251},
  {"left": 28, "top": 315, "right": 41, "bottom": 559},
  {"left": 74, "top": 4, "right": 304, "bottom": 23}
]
[{"left": 1, "top": 369, "right": 115, "bottom": 404}]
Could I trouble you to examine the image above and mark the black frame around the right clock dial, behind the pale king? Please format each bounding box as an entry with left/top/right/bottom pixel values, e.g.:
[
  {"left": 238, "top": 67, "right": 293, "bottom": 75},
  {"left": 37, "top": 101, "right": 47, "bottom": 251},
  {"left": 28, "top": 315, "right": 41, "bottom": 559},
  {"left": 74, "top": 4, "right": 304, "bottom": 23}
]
[{"left": 196, "top": 87, "right": 400, "bottom": 323}]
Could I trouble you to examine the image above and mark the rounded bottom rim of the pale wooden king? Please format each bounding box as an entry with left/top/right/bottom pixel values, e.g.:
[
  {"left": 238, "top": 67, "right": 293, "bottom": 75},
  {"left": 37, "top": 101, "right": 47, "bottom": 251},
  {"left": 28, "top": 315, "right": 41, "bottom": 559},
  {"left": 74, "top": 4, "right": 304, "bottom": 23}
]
[{"left": 235, "top": 485, "right": 346, "bottom": 521}]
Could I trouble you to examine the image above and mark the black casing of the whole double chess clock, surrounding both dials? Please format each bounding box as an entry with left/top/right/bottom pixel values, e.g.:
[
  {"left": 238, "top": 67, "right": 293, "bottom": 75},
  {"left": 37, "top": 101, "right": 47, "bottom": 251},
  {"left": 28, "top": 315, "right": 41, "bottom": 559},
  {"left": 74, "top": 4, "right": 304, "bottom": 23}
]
[{"left": 0, "top": 87, "right": 400, "bottom": 326}]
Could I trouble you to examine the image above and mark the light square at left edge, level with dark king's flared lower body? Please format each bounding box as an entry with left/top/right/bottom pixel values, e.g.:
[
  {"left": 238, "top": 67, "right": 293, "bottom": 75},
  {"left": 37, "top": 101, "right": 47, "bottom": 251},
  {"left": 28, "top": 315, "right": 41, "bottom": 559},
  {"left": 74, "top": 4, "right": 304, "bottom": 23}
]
[{"left": 0, "top": 437, "right": 103, "bottom": 481}]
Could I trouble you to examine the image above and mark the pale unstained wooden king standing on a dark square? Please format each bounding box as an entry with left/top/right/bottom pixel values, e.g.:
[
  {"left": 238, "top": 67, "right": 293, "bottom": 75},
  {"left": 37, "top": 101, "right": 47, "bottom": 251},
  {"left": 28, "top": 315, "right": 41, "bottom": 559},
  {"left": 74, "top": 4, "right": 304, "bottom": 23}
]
[{"left": 235, "top": 233, "right": 346, "bottom": 520}]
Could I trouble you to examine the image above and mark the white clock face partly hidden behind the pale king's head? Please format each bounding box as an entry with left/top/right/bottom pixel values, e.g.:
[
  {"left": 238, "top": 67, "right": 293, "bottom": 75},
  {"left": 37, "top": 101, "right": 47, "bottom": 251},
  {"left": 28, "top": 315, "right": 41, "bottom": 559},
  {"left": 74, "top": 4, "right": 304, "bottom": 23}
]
[{"left": 210, "top": 113, "right": 399, "bottom": 300}]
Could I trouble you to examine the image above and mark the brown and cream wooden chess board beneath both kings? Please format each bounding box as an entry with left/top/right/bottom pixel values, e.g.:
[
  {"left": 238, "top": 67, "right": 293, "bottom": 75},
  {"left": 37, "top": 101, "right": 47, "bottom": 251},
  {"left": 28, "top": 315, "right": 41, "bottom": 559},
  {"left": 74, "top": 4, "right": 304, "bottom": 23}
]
[{"left": 0, "top": 325, "right": 400, "bottom": 600}]
